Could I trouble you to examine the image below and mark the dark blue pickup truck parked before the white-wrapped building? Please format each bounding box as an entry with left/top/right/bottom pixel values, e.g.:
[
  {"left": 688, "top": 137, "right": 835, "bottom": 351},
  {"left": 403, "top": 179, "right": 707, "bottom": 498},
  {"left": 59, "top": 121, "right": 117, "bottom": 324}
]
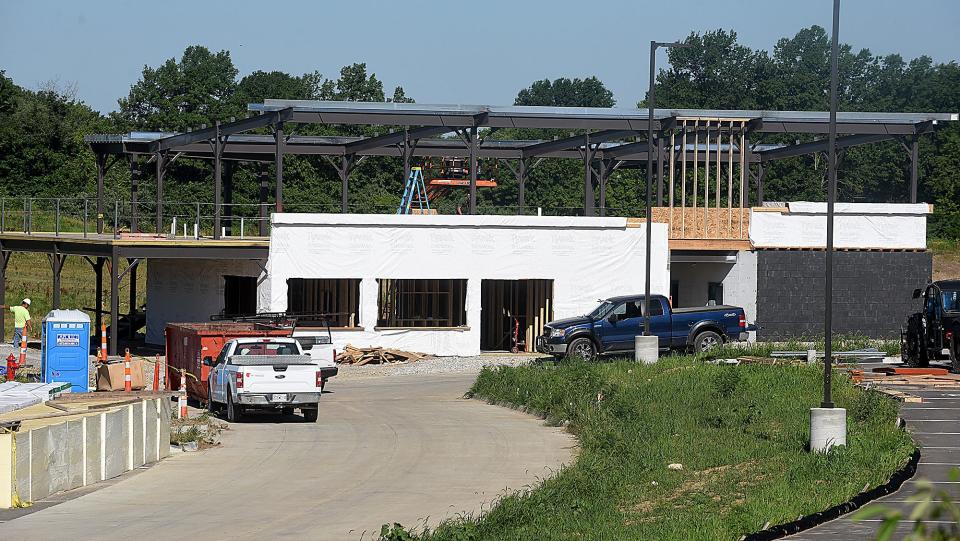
[{"left": 537, "top": 295, "right": 757, "bottom": 360}]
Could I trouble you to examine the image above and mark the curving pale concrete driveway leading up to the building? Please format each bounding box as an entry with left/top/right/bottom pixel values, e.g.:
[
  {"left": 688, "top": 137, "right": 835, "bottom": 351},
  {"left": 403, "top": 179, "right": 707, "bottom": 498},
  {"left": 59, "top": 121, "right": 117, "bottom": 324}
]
[{"left": 0, "top": 374, "right": 575, "bottom": 540}]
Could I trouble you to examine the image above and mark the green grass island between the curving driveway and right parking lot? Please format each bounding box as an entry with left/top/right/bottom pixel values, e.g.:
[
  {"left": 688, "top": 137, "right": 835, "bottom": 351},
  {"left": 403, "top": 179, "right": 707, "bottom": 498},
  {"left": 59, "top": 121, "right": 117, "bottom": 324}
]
[{"left": 384, "top": 357, "right": 914, "bottom": 541}]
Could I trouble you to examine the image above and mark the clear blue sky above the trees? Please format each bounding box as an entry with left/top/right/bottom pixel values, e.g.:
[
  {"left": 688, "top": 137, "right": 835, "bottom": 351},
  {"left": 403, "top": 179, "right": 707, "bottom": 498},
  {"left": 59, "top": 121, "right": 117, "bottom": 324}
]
[{"left": 0, "top": 0, "right": 960, "bottom": 112}]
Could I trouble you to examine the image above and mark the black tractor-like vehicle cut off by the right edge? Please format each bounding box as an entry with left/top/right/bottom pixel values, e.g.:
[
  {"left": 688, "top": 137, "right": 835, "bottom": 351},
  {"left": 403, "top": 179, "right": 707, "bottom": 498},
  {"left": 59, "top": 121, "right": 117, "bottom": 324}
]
[{"left": 900, "top": 280, "right": 960, "bottom": 372}]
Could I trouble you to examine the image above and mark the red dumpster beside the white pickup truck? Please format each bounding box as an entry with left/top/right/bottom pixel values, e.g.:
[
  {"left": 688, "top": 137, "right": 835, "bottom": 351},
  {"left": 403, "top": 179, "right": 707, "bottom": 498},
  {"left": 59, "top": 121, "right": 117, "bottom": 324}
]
[{"left": 165, "top": 322, "right": 293, "bottom": 400}]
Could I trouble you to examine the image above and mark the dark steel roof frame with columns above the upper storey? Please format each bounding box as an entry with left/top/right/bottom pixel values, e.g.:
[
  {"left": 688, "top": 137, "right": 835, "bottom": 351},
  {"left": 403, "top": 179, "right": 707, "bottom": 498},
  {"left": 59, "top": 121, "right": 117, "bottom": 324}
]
[{"left": 85, "top": 100, "right": 960, "bottom": 220}]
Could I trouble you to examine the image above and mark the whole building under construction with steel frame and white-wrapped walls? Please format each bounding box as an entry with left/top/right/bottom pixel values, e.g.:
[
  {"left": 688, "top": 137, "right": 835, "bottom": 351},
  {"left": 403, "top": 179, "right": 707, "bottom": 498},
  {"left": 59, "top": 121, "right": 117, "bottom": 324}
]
[{"left": 0, "top": 100, "right": 958, "bottom": 354}]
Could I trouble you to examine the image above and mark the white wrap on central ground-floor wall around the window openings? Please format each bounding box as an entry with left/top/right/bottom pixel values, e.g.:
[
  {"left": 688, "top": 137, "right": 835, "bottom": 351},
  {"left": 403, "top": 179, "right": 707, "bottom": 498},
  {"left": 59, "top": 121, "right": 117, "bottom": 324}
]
[{"left": 260, "top": 214, "right": 670, "bottom": 355}]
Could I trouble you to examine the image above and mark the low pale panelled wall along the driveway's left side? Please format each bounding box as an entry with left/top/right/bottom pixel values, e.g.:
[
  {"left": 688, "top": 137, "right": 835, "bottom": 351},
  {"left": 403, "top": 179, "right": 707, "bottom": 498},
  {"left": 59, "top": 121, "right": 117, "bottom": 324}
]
[{"left": 0, "top": 398, "right": 170, "bottom": 508}]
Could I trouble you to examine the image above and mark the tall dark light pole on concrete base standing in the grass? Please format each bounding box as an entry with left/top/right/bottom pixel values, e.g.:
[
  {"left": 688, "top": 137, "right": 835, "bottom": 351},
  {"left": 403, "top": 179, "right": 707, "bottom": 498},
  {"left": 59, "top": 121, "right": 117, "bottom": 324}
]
[{"left": 810, "top": 0, "right": 847, "bottom": 451}]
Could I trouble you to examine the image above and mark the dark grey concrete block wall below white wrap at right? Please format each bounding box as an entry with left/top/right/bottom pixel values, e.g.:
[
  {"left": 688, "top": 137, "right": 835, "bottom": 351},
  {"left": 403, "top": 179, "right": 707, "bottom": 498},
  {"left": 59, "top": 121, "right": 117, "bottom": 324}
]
[{"left": 757, "top": 250, "right": 933, "bottom": 340}]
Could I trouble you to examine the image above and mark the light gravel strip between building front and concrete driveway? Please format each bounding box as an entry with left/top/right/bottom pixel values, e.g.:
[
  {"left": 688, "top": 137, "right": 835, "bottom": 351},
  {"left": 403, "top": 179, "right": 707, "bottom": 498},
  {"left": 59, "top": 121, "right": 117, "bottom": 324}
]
[{"left": 333, "top": 354, "right": 550, "bottom": 382}]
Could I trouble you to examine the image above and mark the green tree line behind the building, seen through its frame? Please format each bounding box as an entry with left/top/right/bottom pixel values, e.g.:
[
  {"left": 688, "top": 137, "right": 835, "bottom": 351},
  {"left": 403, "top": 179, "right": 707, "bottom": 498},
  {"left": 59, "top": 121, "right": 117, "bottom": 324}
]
[{"left": 0, "top": 26, "right": 960, "bottom": 234}]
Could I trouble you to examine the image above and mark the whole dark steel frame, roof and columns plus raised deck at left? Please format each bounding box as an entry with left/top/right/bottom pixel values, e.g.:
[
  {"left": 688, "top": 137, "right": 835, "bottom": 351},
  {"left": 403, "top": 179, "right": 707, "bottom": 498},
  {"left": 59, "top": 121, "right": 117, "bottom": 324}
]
[{"left": 9, "top": 100, "right": 944, "bottom": 354}]
